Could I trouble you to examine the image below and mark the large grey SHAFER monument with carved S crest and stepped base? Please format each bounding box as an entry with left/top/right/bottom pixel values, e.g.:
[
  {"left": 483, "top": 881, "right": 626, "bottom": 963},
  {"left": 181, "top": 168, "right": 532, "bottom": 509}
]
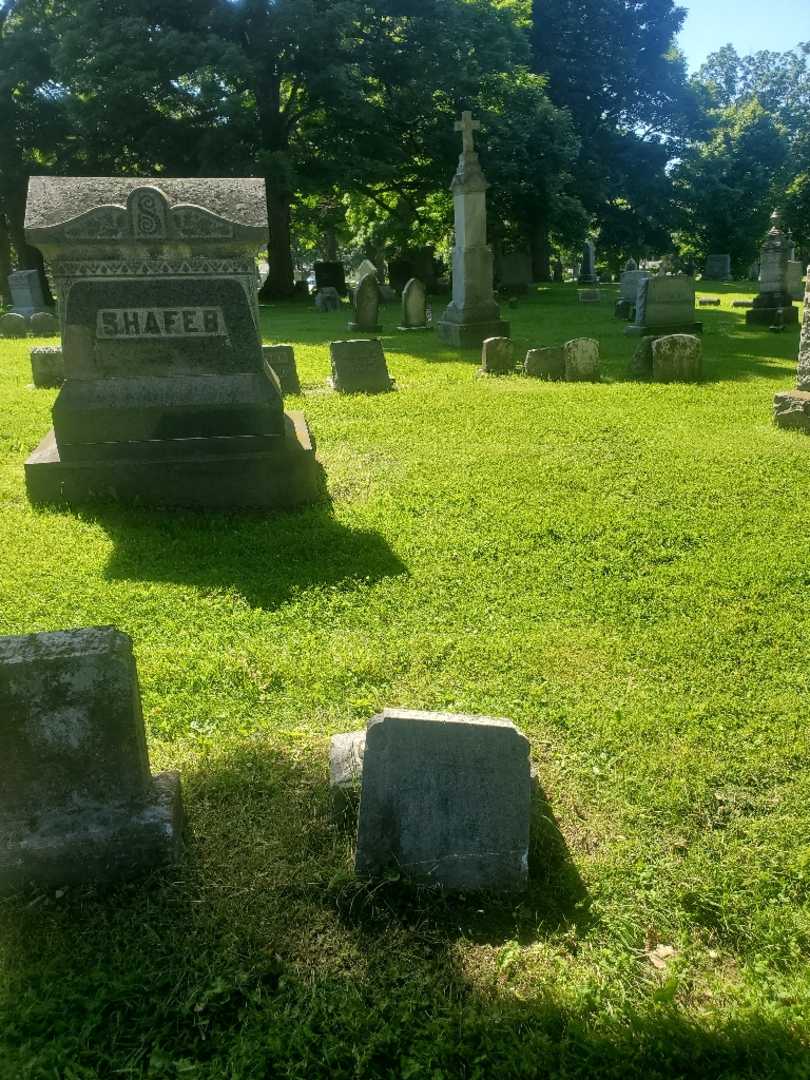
[{"left": 26, "top": 177, "right": 321, "bottom": 509}]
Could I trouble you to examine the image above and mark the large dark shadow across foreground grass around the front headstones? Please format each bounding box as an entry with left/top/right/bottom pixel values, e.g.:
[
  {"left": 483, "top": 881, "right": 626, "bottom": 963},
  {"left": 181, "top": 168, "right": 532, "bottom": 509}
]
[{"left": 0, "top": 735, "right": 808, "bottom": 1080}]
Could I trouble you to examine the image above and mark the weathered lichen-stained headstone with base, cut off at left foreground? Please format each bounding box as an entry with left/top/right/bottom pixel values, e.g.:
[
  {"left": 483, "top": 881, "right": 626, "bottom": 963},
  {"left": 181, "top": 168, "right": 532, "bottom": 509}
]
[{"left": 0, "top": 626, "right": 181, "bottom": 891}]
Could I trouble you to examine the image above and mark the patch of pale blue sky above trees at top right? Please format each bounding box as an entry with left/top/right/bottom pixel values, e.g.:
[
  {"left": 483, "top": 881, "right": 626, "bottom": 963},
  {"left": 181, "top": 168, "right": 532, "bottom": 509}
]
[{"left": 678, "top": 0, "right": 810, "bottom": 71}]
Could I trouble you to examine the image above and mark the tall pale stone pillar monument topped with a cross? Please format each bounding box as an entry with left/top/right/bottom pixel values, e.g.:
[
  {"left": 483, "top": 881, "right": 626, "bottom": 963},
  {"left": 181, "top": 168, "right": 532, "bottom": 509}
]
[{"left": 438, "top": 112, "right": 509, "bottom": 349}]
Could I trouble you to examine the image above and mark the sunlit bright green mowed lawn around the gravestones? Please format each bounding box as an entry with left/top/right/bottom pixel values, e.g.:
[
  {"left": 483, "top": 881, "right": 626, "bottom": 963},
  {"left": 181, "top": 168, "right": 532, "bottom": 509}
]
[{"left": 0, "top": 286, "right": 810, "bottom": 1080}]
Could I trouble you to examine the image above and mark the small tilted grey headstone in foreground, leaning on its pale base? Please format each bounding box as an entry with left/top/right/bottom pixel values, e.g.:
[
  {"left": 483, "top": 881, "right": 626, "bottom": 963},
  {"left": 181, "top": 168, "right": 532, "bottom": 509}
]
[{"left": 332, "top": 708, "right": 531, "bottom": 892}]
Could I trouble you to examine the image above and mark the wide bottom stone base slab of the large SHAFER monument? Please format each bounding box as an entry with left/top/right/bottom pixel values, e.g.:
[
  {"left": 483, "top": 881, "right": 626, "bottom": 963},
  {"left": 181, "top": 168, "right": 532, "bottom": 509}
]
[{"left": 25, "top": 413, "right": 322, "bottom": 510}]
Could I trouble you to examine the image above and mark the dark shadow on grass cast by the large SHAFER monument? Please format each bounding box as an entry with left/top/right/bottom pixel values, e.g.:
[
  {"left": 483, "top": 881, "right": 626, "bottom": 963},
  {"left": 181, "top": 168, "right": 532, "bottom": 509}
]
[{"left": 77, "top": 502, "right": 407, "bottom": 609}]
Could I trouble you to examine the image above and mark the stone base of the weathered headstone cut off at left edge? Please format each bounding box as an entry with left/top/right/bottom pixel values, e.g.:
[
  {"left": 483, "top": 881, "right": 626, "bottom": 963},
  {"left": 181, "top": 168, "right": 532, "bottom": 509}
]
[{"left": 0, "top": 772, "right": 183, "bottom": 893}]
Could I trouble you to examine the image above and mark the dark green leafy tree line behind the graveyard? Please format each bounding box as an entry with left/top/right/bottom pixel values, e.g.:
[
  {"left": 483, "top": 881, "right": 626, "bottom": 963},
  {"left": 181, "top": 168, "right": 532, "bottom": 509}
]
[{"left": 0, "top": 0, "right": 810, "bottom": 306}]
